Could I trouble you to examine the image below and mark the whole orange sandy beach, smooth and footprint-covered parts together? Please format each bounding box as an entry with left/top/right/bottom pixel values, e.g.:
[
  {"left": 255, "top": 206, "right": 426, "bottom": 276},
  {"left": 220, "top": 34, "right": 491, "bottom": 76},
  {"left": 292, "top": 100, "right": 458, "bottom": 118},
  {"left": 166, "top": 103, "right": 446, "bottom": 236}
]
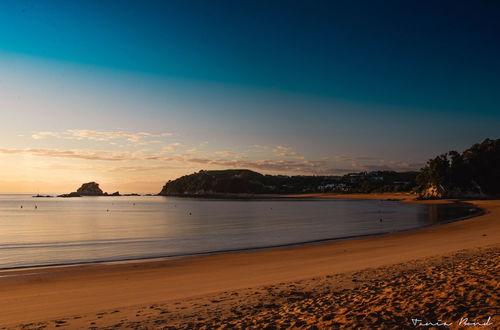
[{"left": 0, "top": 194, "right": 500, "bottom": 329}]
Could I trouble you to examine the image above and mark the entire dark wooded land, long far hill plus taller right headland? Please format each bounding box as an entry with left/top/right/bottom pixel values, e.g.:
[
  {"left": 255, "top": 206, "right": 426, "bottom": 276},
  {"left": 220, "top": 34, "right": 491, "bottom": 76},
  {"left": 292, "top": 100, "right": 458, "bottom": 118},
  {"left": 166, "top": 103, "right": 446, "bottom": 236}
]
[{"left": 160, "top": 139, "right": 500, "bottom": 198}]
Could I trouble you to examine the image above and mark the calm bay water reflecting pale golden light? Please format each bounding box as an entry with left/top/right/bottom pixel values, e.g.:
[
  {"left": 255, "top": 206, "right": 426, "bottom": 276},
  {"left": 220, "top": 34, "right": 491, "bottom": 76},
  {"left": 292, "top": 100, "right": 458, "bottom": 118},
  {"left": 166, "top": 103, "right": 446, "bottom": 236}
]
[{"left": 0, "top": 195, "right": 471, "bottom": 268}]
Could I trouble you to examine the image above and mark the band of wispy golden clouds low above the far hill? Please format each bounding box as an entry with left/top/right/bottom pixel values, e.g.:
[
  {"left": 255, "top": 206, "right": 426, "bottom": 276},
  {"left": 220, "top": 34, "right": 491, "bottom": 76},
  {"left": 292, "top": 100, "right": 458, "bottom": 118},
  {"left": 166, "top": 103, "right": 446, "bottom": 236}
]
[{"left": 0, "top": 129, "right": 423, "bottom": 179}]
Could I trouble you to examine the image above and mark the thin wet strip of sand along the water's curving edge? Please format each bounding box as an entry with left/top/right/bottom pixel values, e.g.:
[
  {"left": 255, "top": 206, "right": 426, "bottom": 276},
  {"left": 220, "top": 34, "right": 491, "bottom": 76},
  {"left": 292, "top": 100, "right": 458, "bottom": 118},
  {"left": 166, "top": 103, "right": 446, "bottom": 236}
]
[{"left": 0, "top": 193, "right": 486, "bottom": 272}]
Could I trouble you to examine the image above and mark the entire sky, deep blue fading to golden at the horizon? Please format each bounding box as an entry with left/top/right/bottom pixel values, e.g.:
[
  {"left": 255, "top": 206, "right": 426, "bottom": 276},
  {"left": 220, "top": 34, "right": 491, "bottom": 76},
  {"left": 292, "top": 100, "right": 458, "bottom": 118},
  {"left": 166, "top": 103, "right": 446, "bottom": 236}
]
[{"left": 0, "top": 0, "right": 500, "bottom": 193}]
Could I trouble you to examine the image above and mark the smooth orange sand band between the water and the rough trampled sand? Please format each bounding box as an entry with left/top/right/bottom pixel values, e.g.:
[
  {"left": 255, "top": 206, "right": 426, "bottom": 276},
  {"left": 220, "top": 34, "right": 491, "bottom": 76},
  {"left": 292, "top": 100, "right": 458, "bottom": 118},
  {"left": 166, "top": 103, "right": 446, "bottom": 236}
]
[{"left": 0, "top": 195, "right": 500, "bottom": 328}]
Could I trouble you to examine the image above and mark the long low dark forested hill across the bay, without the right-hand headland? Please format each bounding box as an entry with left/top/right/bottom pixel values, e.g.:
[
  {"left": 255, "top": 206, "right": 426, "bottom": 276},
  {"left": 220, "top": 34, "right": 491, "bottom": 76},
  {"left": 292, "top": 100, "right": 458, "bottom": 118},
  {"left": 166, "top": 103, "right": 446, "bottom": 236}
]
[{"left": 160, "top": 169, "right": 418, "bottom": 196}]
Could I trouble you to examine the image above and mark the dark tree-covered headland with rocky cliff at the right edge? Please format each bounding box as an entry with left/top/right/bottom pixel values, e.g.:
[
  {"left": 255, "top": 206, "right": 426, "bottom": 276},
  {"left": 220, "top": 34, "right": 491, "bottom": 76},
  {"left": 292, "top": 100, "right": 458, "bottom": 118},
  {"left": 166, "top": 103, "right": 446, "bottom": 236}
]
[{"left": 417, "top": 139, "right": 500, "bottom": 198}]
